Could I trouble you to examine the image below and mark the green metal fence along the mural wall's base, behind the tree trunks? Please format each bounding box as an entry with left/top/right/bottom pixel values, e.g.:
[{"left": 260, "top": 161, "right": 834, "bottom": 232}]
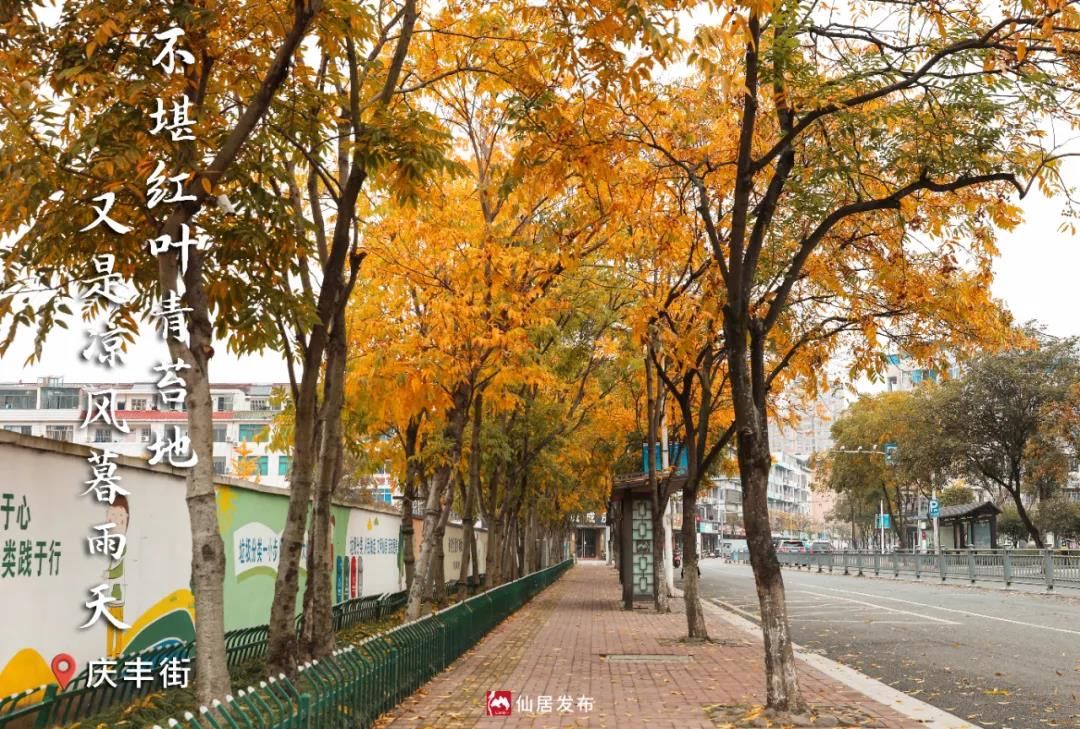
[{"left": 0, "top": 591, "right": 408, "bottom": 729}]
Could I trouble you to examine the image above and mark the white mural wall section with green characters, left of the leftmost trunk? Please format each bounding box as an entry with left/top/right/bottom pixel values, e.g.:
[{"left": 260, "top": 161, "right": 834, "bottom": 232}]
[{"left": 0, "top": 433, "right": 194, "bottom": 696}]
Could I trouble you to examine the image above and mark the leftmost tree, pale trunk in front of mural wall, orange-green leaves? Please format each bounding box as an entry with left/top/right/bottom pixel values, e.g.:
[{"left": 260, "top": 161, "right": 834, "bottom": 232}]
[{"left": 0, "top": 0, "right": 322, "bottom": 702}]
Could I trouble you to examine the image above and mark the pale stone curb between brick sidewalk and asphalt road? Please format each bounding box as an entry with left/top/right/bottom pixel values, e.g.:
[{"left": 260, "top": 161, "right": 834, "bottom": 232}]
[{"left": 691, "top": 590, "right": 982, "bottom": 729}]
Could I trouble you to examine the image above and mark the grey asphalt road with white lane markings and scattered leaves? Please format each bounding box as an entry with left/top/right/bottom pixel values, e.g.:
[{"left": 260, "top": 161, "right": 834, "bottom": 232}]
[{"left": 701, "top": 559, "right": 1080, "bottom": 729}]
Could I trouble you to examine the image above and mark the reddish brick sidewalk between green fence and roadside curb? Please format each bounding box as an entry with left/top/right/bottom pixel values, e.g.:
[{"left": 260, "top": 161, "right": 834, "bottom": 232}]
[{"left": 379, "top": 564, "right": 922, "bottom": 729}]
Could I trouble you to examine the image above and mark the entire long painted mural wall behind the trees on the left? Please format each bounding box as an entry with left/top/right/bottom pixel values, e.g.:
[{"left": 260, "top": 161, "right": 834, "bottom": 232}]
[{"left": 0, "top": 431, "right": 486, "bottom": 697}]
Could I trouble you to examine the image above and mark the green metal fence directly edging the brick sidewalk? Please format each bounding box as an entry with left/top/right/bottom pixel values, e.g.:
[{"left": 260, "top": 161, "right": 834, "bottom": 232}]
[{"left": 156, "top": 561, "right": 573, "bottom": 729}]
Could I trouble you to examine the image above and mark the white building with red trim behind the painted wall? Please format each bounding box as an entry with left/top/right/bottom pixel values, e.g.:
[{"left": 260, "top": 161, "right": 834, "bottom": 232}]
[{"left": 0, "top": 377, "right": 292, "bottom": 486}]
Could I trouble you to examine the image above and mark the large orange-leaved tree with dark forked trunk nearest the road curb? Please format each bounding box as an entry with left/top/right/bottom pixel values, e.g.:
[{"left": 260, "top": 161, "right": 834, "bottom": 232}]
[{"left": 626, "top": 0, "right": 1077, "bottom": 711}]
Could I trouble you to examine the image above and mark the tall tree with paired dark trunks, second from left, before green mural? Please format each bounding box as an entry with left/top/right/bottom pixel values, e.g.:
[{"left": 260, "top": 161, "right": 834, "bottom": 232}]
[{"left": 236, "top": 0, "right": 460, "bottom": 671}]
